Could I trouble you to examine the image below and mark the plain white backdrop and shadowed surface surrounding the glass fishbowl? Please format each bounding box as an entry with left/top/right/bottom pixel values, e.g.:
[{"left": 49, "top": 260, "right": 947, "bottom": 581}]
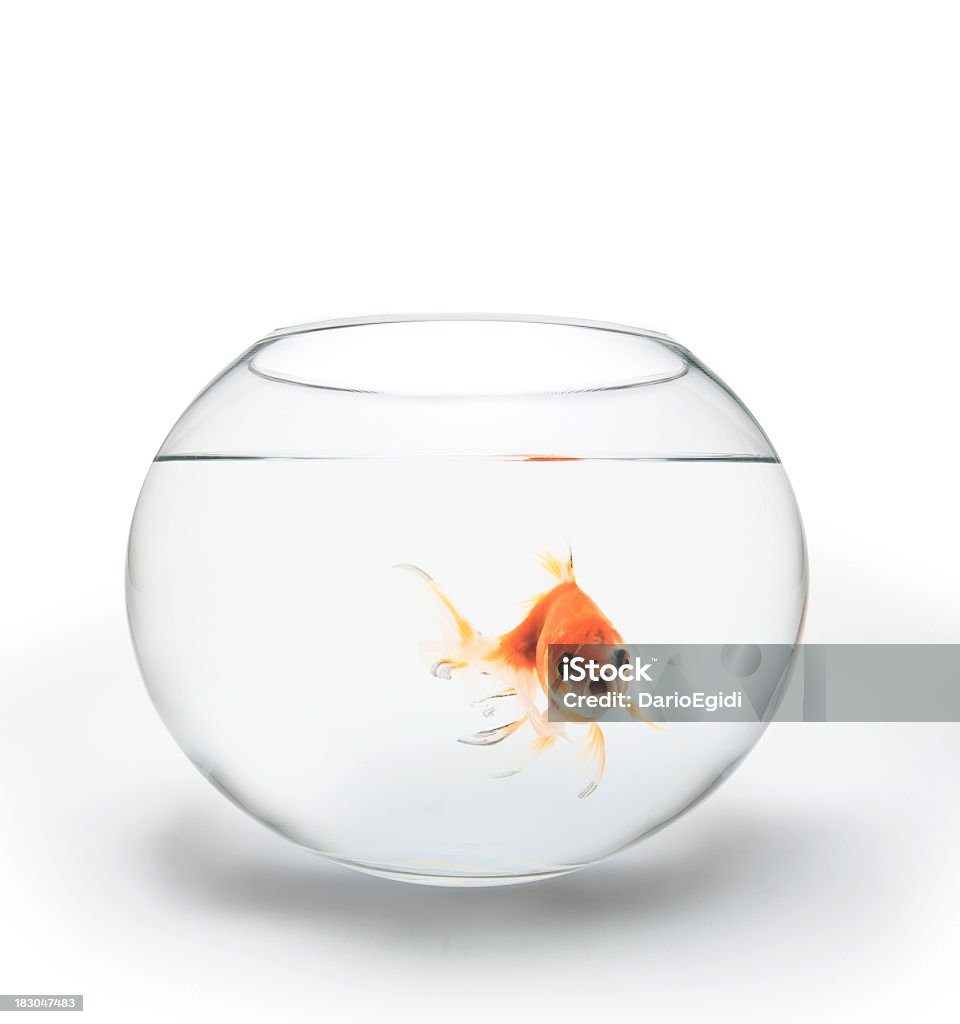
[{"left": 0, "top": 0, "right": 960, "bottom": 1021}]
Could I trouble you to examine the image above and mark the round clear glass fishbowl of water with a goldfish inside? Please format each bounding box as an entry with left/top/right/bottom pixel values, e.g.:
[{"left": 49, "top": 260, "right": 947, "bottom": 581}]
[{"left": 127, "top": 316, "right": 806, "bottom": 885}]
